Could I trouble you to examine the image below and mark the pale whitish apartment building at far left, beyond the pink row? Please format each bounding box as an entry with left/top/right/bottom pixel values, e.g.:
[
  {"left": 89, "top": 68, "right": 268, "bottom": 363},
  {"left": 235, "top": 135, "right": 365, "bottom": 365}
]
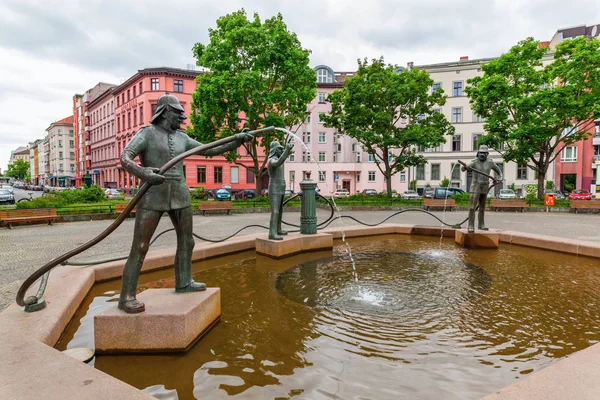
[{"left": 45, "top": 115, "right": 76, "bottom": 187}]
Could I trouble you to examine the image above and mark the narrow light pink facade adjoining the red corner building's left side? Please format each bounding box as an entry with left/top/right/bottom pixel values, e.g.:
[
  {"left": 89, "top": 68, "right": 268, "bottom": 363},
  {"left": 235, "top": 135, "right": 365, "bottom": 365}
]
[{"left": 85, "top": 88, "right": 118, "bottom": 188}]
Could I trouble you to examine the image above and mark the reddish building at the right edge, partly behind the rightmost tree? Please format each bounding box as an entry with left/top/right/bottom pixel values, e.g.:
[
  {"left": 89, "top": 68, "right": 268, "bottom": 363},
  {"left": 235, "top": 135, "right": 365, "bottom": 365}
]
[{"left": 555, "top": 120, "right": 600, "bottom": 197}]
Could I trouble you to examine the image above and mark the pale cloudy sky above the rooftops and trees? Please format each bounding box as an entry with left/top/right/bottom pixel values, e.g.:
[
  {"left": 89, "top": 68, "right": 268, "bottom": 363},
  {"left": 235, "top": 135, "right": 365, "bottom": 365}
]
[{"left": 0, "top": 0, "right": 600, "bottom": 171}]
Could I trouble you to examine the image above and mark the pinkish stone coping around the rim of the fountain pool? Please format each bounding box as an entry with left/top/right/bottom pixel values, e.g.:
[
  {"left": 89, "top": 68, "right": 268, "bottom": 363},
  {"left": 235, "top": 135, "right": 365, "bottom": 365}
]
[{"left": 0, "top": 224, "right": 600, "bottom": 400}]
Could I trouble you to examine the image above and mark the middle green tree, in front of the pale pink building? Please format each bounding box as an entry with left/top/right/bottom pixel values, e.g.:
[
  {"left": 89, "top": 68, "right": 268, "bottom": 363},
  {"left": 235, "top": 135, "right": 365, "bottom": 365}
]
[{"left": 325, "top": 57, "right": 454, "bottom": 196}]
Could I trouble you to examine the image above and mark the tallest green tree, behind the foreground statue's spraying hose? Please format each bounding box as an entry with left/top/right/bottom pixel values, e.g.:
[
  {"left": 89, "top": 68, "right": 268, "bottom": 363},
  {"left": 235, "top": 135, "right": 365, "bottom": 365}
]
[{"left": 188, "top": 9, "right": 317, "bottom": 194}]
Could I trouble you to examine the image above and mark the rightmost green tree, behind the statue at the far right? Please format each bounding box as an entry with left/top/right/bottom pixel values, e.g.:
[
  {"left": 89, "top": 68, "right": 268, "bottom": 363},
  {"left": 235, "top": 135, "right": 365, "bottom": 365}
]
[{"left": 465, "top": 37, "right": 600, "bottom": 199}]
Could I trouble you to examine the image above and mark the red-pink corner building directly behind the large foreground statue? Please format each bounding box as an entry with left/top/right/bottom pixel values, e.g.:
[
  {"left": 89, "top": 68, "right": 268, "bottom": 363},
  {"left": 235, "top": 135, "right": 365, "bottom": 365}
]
[{"left": 113, "top": 67, "right": 262, "bottom": 191}]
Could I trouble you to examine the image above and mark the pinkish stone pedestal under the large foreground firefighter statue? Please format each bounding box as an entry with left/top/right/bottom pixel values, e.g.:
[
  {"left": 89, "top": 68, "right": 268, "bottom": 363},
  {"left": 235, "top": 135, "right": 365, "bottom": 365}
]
[{"left": 94, "top": 288, "right": 221, "bottom": 353}]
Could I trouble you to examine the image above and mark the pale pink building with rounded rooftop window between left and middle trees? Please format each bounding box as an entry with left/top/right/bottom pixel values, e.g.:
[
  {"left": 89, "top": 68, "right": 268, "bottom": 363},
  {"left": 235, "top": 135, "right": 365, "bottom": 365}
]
[{"left": 285, "top": 65, "right": 408, "bottom": 194}]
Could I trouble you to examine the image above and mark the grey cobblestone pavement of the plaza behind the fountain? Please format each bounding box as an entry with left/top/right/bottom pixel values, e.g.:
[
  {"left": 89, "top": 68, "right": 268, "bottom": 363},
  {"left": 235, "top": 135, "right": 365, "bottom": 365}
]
[{"left": 0, "top": 210, "right": 600, "bottom": 310}]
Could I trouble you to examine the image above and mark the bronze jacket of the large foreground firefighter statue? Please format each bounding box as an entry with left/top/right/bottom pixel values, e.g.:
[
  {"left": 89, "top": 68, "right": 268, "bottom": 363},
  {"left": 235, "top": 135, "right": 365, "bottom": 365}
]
[{"left": 121, "top": 125, "right": 239, "bottom": 211}]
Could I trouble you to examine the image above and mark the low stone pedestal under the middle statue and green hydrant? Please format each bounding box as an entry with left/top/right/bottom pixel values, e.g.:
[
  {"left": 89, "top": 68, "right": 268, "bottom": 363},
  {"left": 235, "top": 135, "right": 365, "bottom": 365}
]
[{"left": 256, "top": 233, "right": 333, "bottom": 258}]
